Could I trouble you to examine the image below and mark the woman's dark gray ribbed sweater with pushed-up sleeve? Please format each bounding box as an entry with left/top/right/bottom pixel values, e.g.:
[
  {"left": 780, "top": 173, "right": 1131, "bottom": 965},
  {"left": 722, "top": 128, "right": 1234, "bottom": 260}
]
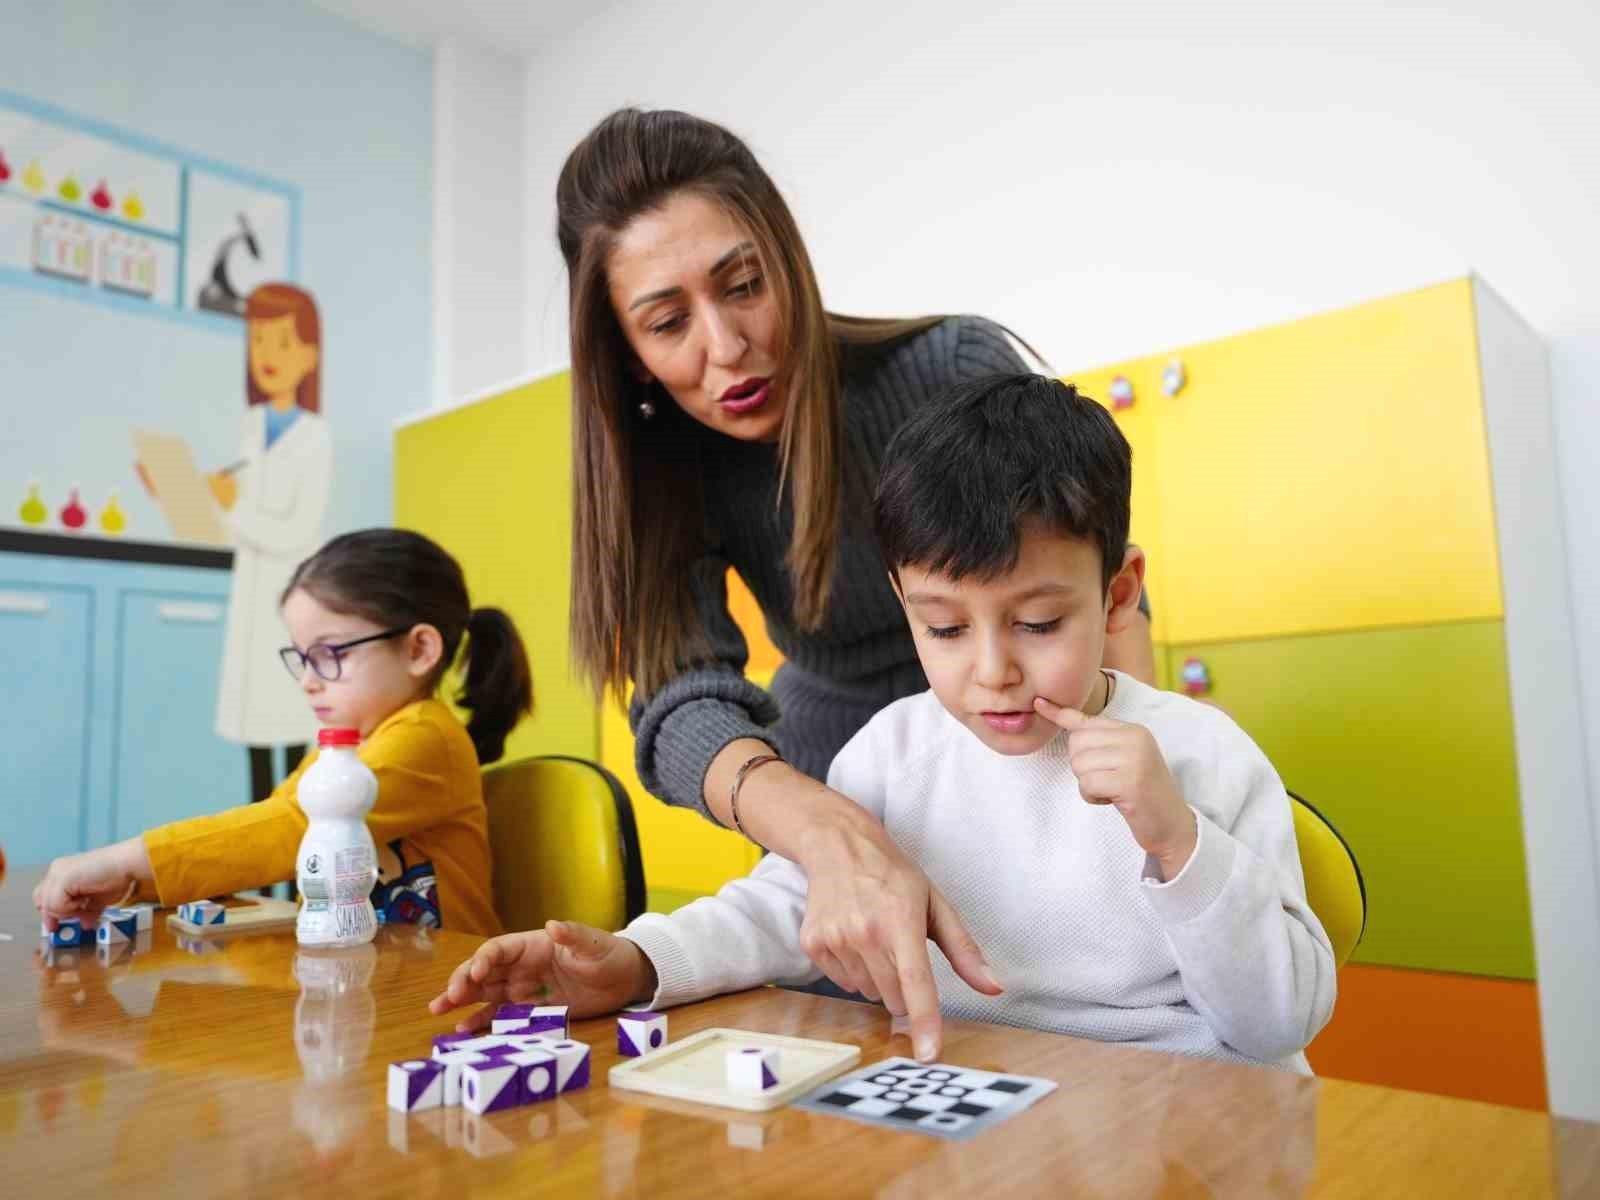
[{"left": 630, "top": 317, "right": 1027, "bottom": 811}]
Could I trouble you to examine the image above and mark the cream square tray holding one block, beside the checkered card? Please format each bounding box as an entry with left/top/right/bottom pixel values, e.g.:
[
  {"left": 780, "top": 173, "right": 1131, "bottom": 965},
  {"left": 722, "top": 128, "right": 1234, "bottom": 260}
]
[{"left": 610, "top": 1029, "right": 861, "bottom": 1112}]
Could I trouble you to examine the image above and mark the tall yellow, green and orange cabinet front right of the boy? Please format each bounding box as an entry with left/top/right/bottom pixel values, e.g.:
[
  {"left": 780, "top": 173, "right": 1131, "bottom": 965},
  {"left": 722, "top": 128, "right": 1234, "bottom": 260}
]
[{"left": 1067, "top": 280, "right": 1542, "bottom": 1104}]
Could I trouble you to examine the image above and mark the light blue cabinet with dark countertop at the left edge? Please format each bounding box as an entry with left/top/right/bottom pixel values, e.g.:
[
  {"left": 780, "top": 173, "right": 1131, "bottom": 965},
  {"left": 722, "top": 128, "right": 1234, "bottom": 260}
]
[{"left": 0, "top": 530, "right": 250, "bottom": 866}]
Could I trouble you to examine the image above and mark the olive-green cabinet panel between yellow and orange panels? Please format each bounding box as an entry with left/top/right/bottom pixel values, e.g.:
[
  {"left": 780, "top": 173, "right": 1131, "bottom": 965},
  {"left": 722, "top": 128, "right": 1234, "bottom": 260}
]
[{"left": 1166, "top": 621, "right": 1534, "bottom": 979}]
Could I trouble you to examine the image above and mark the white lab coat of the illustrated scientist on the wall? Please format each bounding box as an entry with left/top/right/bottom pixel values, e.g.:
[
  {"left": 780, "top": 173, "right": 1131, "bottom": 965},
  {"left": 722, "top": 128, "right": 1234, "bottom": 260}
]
[{"left": 216, "top": 405, "right": 333, "bottom": 746}]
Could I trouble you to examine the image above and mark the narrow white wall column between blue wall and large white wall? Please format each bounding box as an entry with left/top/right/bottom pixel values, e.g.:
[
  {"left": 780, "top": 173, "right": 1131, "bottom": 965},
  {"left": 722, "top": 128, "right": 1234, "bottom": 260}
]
[{"left": 434, "top": 38, "right": 528, "bottom": 406}]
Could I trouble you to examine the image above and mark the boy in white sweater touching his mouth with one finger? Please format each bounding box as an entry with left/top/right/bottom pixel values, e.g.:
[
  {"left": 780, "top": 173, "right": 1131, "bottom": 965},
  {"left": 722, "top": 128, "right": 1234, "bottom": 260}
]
[{"left": 432, "top": 374, "right": 1334, "bottom": 1072}]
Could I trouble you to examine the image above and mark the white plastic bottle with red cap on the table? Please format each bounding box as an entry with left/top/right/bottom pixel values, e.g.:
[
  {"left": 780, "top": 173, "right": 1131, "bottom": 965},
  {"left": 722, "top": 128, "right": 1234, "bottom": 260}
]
[{"left": 294, "top": 730, "right": 378, "bottom": 946}]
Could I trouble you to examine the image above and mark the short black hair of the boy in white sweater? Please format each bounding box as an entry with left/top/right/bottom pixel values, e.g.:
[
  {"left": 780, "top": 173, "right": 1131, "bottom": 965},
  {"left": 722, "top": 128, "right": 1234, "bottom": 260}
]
[{"left": 874, "top": 374, "right": 1133, "bottom": 586}]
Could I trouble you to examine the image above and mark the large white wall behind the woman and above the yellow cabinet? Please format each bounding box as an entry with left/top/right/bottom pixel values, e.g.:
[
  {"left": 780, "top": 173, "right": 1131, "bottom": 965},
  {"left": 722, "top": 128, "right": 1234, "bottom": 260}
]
[{"left": 526, "top": 0, "right": 1600, "bottom": 1117}]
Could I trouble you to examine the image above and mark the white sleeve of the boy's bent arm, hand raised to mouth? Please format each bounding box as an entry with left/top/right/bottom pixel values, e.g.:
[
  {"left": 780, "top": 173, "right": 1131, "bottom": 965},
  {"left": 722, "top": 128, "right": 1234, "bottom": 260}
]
[{"left": 1144, "top": 739, "right": 1336, "bottom": 1061}]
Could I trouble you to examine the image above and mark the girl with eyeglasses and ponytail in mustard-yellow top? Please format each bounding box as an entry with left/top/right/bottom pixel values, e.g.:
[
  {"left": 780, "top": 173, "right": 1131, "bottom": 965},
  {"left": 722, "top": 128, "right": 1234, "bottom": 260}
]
[{"left": 34, "top": 530, "right": 533, "bottom": 936}]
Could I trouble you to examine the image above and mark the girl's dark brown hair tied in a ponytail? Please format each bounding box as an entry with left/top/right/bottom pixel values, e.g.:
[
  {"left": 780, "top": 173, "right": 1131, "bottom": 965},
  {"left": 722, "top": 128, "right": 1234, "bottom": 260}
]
[{"left": 280, "top": 530, "right": 533, "bottom": 763}]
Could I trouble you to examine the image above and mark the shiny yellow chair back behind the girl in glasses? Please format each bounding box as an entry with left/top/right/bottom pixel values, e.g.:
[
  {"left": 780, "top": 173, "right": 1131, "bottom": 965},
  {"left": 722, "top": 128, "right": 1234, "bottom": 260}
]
[{"left": 483, "top": 755, "right": 645, "bottom": 931}]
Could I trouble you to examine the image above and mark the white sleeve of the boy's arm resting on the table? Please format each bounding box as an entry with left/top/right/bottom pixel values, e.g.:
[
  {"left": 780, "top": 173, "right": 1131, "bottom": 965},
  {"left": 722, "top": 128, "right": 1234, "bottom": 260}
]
[{"left": 621, "top": 730, "right": 883, "bottom": 1008}]
